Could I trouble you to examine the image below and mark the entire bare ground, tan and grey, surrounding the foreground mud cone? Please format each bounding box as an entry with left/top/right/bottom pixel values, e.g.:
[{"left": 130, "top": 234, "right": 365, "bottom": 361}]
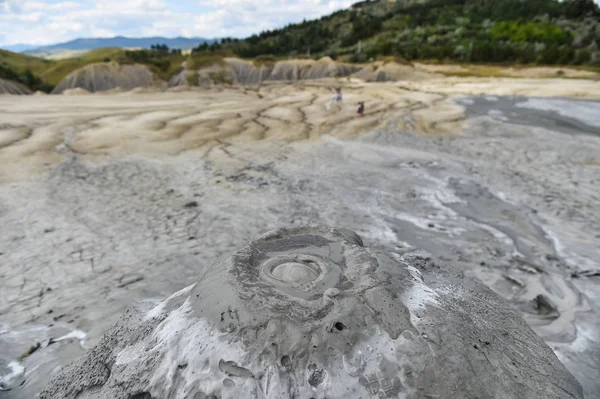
[{"left": 0, "top": 78, "right": 600, "bottom": 398}]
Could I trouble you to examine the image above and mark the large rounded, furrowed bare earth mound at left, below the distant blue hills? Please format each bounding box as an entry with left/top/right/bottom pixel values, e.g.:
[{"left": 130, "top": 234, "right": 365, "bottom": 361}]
[{"left": 53, "top": 62, "right": 154, "bottom": 94}]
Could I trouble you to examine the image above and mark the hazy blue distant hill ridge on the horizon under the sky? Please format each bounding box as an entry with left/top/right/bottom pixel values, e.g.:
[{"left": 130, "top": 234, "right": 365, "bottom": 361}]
[{"left": 22, "top": 36, "right": 214, "bottom": 56}]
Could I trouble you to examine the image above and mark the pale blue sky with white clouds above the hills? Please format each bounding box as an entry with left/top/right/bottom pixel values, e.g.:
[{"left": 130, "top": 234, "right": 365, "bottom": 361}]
[{"left": 0, "top": 0, "right": 358, "bottom": 46}]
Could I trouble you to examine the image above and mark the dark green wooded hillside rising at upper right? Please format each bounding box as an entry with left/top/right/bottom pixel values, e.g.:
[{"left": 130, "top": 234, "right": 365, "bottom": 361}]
[{"left": 194, "top": 0, "right": 600, "bottom": 65}]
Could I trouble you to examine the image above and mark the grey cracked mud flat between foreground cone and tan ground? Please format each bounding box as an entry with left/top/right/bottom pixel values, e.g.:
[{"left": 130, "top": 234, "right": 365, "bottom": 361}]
[{"left": 0, "top": 98, "right": 600, "bottom": 399}]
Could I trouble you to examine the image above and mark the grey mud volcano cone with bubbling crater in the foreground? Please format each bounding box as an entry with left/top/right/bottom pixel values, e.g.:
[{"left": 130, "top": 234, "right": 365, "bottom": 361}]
[{"left": 41, "top": 227, "right": 583, "bottom": 399}]
